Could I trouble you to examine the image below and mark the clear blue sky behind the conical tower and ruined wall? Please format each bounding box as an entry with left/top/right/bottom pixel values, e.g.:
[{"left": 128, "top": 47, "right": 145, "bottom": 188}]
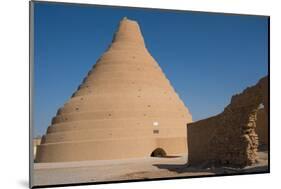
[{"left": 34, "top": 3, "right": 268, "bottom": 135}]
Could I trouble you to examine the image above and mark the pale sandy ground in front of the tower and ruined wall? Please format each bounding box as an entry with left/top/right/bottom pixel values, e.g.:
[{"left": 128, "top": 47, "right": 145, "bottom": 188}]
[{"left": 33, "top": 151, "right": 268, "bottom": 186}]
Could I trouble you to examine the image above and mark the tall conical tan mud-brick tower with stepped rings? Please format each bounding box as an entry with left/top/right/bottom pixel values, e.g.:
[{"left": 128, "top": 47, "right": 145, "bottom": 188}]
[{"left": 36, "top": 18, "right": 192, "bottom": 162}]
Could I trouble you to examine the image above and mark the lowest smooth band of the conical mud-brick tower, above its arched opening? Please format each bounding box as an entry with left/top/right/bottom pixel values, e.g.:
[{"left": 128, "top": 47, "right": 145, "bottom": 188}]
[{"left": 36, "top": 136, "right": 186, "bottom": 162}]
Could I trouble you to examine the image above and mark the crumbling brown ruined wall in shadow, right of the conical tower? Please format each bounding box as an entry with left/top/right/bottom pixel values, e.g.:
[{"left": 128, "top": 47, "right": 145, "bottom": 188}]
[{"left": 187, "top": 77, "right": 268, "bottom": 167}]
